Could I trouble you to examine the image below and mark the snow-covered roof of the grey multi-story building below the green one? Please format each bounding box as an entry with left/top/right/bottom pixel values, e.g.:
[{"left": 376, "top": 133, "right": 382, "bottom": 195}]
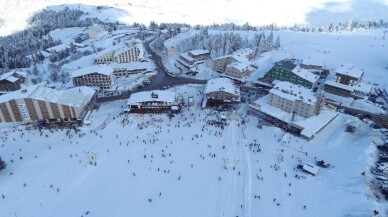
[{"left": 269, "top": 81, "right": 317, "bottom": 105}]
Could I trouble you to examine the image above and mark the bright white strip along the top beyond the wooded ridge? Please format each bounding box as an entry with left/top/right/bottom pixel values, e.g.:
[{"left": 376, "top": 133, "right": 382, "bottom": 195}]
[{"left": 0, "top": 0, "right": 388, "bottom": 35}]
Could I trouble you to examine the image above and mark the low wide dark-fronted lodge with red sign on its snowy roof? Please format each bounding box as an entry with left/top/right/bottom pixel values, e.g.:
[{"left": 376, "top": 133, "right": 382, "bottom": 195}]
[{"left": 127, "top": 90, "right": 181, "bottom": 113}]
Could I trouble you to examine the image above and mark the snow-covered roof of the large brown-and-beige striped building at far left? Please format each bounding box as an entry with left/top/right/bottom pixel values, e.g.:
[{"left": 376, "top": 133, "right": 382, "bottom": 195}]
[{"left": 0, "top": 83, "right": 95, "bottom": 106}]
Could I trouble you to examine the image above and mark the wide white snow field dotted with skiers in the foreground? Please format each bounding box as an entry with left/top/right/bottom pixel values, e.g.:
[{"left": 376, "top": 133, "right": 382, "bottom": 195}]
[{"left": 0, "top": 85, "right": 387, "bottom": 217}]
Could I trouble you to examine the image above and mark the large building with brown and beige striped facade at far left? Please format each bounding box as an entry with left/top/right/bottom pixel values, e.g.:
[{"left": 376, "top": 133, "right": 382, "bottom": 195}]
[{"left": 0, "top": 83, "right": 95, "bottom": 123}]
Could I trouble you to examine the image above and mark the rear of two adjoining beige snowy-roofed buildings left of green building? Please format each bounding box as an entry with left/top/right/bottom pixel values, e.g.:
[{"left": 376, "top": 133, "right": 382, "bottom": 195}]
[{"left": 212, "top": 48, "right": 255, "bottom": 73}]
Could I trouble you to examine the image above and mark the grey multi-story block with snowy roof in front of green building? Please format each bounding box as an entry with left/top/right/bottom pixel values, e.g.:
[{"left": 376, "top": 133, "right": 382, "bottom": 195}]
[{"left": 268, "top": 82, "right": 325, "bottom": 117}]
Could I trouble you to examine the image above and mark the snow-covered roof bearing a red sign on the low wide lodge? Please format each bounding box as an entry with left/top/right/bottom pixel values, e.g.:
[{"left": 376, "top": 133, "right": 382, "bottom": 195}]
[{"left": 127, "top": 90, "right": 175, "bottom": 105}]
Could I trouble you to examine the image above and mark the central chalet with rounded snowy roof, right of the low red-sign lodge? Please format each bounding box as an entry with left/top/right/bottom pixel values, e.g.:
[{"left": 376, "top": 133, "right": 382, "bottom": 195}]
[{"left": 205, "top": 78, "right": 241, "bottom": 106}]
